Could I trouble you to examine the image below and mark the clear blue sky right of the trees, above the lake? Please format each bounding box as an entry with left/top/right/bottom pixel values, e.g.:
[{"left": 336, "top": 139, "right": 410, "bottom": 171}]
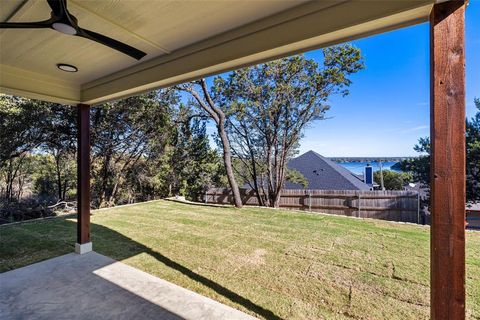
[{"left": 203, "top": 0, "right": 480, "bottom": 156}]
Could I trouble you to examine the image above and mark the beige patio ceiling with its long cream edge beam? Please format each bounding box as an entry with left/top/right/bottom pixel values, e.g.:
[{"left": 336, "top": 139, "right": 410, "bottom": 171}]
[{"left": 0, "top": 0, "right": 435, "bottom": 104}]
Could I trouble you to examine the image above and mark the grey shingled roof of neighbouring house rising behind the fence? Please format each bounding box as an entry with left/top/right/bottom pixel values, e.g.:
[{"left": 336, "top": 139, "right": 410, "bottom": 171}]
[{"left": 285, "top": 151, "right": 370, "bottom": 190}]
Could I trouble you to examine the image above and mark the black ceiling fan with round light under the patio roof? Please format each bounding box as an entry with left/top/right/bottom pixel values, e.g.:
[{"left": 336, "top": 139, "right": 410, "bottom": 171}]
[{"left": 0, "top": 0, "right": 146, "bottom": 60}]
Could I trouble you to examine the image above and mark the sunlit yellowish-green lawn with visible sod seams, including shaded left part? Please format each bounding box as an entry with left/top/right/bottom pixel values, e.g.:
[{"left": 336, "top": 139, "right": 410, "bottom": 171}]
[{"left": 0, "top": 201, "right": 480, "bottom": 319}]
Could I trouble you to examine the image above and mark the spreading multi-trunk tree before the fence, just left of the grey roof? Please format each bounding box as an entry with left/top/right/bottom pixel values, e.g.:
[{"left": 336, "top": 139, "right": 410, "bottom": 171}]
[{"left": 212, "top": 44, "right": 364, "bottom": 207}]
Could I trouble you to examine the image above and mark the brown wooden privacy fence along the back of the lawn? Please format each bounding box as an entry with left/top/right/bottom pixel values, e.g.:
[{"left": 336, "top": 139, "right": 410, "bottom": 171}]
[{"left": 203, "top": 188, "right": 421, "bottom": 223}]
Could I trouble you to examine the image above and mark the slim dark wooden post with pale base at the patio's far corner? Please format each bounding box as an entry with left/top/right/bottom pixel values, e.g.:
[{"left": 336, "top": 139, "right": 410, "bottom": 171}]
[{"left": 76, "top": 104, "right": 92, "bottom": 253}]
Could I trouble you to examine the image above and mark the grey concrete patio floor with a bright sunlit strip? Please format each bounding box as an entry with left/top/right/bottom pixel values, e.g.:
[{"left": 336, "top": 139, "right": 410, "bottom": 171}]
[{"left": 0, "top": 252, "right": 255, "bottom": 320}]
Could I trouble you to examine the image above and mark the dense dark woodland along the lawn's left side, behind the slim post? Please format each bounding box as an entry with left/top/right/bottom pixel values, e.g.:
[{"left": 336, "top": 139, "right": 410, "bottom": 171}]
[{"left": 0, "top": 90, "right": 225, "bottom": 219}]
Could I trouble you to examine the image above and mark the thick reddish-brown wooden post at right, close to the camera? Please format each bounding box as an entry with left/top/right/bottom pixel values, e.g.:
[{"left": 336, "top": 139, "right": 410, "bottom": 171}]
[{"left": 430, "top": 0, "right": 465, "bottom": 320}]
